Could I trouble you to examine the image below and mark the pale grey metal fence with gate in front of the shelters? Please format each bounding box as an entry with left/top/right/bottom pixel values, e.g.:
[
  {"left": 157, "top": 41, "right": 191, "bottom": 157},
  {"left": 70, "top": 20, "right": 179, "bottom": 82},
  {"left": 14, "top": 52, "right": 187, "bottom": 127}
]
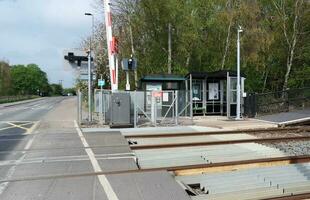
[{"left": 77, "top": 90, "right": 193, "bottom": 127}]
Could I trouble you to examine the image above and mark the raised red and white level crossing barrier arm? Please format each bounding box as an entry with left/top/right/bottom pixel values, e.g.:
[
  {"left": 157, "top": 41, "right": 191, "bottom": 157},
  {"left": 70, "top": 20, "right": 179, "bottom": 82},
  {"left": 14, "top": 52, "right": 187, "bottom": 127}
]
[{"left": 104, "top": 0, "right": 118, "bottom": 92}]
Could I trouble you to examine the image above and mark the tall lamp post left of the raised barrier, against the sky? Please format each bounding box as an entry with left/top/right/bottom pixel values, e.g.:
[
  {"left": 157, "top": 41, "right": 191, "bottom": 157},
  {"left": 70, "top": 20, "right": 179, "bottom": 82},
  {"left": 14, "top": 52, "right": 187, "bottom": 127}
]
[{"left": 85, "top": 13, "right": 94, "bottom": 122}]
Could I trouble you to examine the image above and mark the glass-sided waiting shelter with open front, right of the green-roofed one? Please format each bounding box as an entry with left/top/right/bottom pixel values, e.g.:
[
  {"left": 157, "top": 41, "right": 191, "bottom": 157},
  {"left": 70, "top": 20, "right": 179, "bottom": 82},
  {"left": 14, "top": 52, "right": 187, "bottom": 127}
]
[{"left": 185, "top": 70, "right": 245, "bottom": 117}]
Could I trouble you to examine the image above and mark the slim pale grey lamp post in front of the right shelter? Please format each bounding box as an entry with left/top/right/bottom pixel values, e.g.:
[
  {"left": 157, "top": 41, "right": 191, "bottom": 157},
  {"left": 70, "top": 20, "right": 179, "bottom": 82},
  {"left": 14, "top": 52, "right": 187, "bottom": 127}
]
[{"left": 236, "top": 26, "right": 243, "bottom": 120}]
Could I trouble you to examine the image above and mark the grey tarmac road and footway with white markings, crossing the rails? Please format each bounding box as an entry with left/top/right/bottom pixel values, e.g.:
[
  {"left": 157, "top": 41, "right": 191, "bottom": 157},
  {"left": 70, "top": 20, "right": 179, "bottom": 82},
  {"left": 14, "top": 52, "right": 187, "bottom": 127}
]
[{"left": 0, "top": 97, "right": 190, "bottom": 200}]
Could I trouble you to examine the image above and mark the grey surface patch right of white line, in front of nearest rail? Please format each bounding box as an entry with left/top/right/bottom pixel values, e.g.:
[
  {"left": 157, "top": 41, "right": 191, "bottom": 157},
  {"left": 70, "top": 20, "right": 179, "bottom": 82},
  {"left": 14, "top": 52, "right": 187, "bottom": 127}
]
[{"left": 107, "top": 171, "right": 190, "bottom": 200}]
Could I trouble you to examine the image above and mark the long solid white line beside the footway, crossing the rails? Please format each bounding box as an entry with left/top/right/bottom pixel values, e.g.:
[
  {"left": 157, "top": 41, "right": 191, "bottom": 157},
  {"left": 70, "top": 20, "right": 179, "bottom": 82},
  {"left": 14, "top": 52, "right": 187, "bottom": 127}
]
[{"left": 74, "top": 120, "right": 119, "bottom": 200}]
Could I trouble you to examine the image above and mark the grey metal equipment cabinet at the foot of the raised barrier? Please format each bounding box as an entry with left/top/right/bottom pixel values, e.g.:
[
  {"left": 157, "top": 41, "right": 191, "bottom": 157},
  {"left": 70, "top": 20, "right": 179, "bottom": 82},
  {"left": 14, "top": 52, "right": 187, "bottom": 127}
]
[{"left": 110, "top": 93, "right": 132, "bottom": 128}]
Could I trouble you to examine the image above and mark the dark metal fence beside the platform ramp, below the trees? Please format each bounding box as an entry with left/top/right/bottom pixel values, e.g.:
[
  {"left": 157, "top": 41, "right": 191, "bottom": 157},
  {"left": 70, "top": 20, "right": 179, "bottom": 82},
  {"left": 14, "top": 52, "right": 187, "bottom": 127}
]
[{"left": 244, "top": 87, "right": 310, "bottom": 117}]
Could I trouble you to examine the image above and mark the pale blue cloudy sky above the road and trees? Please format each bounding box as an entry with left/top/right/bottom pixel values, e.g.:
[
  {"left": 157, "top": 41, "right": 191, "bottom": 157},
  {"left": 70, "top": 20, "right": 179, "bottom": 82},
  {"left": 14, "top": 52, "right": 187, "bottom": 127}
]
[{"left": 0, "top": 0, "right": 102, "bottom": 87}]
